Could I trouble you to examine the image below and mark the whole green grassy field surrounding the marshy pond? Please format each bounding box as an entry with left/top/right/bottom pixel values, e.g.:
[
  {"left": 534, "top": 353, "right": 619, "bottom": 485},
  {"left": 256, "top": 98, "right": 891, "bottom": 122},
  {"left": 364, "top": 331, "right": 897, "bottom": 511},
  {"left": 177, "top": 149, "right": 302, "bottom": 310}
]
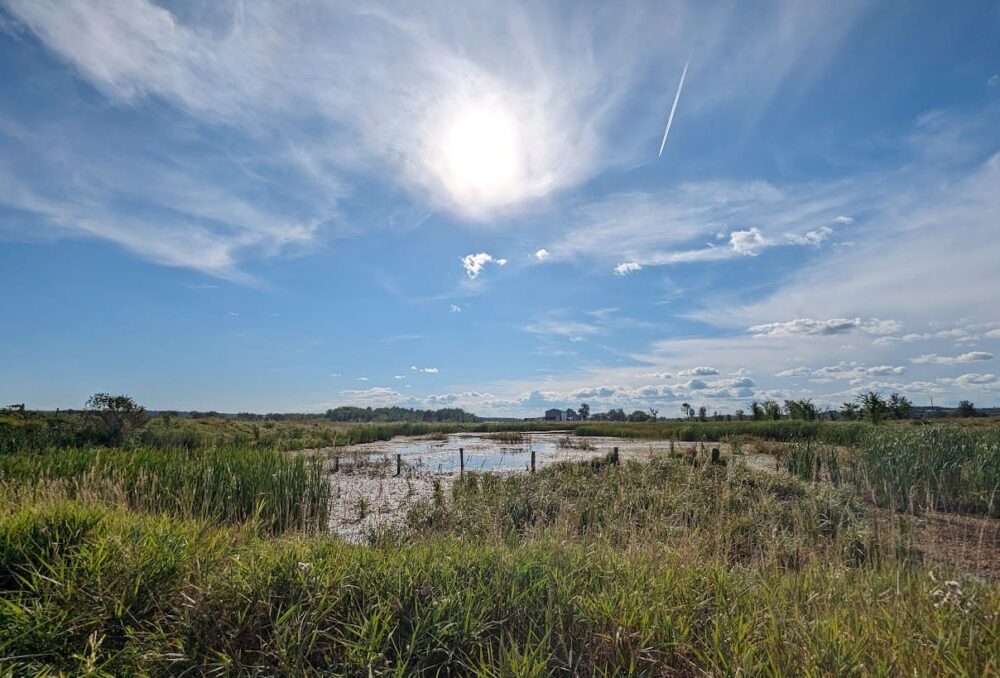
[{"left": 0, "top": 420, "right": 1000, "bottom": 676}]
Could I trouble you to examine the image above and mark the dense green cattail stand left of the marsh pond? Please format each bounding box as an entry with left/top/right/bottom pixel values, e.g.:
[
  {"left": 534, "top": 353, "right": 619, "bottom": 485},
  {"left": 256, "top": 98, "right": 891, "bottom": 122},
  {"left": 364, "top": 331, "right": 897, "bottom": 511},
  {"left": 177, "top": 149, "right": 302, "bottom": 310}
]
[{"left": 0, "top": 447, "right": 330, "bottom": 533}]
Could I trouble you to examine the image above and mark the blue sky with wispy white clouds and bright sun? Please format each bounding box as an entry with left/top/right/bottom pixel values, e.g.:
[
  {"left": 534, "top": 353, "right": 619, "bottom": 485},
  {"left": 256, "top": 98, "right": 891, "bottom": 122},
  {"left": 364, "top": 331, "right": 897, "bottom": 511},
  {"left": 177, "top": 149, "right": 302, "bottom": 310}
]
[{"left": 0, "top": 0, "right": 1000, "bottom": 416}]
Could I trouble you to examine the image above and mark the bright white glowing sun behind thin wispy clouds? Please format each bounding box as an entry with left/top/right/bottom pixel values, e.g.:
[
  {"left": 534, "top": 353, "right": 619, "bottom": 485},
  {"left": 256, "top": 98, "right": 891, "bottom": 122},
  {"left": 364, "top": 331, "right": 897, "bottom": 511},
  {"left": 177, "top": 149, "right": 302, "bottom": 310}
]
[{"left": 435, "top": 100, "right": 524, "bottom": 210}]
